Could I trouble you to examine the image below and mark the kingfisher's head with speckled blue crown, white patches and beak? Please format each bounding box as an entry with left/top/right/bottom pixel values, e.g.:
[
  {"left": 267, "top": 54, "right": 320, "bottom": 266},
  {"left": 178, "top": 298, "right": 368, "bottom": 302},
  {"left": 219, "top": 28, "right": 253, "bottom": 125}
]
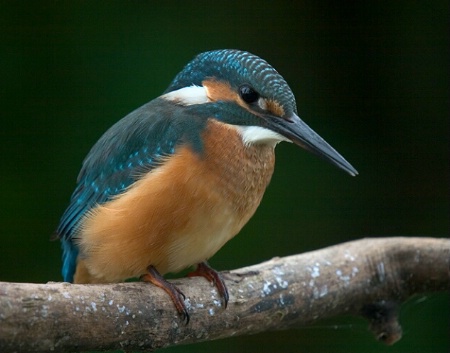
[{"left": 163, "top": 49, "right": 358, "bottom": 176}]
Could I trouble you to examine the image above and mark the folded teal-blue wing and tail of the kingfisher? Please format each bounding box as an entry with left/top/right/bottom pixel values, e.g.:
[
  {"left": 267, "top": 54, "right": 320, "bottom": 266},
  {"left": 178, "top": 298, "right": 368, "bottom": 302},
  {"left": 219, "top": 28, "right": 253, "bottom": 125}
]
[{"left": 56, "top": 99, "right": 200, "bottom": 282}]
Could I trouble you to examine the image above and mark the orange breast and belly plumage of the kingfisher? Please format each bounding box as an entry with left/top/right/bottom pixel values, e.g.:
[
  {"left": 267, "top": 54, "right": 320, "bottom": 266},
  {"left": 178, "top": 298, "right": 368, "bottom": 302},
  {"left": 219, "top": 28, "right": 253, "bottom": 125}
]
[{"left": 75, "top": 120, "right": 275, "bottom": 283}]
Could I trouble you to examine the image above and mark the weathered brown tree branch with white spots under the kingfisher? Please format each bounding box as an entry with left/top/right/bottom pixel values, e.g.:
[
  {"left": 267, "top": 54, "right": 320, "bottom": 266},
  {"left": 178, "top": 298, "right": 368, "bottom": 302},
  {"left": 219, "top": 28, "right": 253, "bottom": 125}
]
[{"left": 0, "top": 238, "right": 450, "bottom": 353}]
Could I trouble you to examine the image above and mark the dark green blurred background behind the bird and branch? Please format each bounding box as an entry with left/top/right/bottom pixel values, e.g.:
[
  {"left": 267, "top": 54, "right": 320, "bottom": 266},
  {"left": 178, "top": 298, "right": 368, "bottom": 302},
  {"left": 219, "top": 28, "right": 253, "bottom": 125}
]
[{"left": 0, "top": 1, "right": 450, "bottom": 353}]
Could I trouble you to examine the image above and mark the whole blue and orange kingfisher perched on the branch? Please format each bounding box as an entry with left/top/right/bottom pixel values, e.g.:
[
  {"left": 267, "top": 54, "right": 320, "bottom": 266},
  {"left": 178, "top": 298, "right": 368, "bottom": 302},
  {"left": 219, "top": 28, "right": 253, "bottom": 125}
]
[{"left": 56, "top": 49, "right": 357, "bottom": 322}]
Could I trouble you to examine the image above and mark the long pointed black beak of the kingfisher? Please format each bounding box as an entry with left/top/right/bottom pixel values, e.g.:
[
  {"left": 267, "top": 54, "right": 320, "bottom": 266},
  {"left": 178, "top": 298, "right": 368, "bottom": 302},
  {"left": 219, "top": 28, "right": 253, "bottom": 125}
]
[{"left": 264, "top": 113, "right": 358, "bottom": 176}]
